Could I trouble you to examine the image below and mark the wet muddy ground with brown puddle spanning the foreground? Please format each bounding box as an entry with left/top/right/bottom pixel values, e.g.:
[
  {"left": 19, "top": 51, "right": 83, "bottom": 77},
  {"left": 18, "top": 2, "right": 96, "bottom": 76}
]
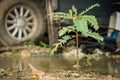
[{"left": 0, "top": 47, "right": 120, "bottom": 80}]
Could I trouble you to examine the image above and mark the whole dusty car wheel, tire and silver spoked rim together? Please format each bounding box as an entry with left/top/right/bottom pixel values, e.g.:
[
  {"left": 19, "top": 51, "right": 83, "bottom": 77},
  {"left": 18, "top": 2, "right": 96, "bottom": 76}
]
[{"left": 0, "top": 0, "right": 45, "bottom": 46}]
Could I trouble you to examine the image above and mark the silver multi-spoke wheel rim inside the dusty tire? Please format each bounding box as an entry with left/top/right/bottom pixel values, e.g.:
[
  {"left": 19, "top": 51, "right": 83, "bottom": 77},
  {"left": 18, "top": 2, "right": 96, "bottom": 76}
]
[{"left": 4, "top": 5, "right": 37, "bottom": 41}]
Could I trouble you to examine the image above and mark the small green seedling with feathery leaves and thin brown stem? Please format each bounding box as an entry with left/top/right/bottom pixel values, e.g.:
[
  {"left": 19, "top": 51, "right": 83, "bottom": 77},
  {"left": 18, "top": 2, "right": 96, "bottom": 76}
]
[{"left": 50, "top": 3, "right": 103, "bottom": 70}]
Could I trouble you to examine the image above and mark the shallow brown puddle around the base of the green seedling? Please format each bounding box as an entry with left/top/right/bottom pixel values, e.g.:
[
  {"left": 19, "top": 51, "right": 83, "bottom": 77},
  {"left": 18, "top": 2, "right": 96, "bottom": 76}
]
[{"left": 0, "top": 54, "right": 120, "bottom": 75}]
